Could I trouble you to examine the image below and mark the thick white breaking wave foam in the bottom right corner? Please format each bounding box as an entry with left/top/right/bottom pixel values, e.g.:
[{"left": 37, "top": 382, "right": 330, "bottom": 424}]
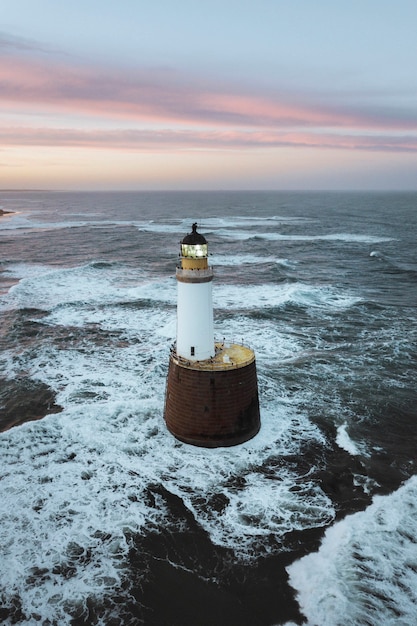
[{"left": 287, "top": 476, "right": 417, "bottom": 626}]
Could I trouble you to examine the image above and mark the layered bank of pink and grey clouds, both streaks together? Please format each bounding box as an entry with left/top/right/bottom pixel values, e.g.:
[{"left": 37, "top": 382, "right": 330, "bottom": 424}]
[{"left": 0, "top": 35, "right": 417, "bottom": 152}]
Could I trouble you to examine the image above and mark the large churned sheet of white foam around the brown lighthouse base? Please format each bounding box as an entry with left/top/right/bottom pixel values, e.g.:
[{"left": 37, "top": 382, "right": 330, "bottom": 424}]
[{"left": 0, "top": 352, "right": 334, "bottom": 621}]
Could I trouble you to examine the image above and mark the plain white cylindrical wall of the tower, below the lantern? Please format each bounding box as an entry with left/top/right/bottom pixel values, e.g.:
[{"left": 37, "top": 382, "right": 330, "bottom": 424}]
[{"left": 177, "top": 270, "right": 215, "bottom": 361}]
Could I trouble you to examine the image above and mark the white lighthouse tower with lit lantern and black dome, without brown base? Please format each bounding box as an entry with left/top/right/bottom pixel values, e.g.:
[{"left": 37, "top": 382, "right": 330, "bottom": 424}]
[{"left": 176, "top": 224, "right": 215, "bottom": 361}]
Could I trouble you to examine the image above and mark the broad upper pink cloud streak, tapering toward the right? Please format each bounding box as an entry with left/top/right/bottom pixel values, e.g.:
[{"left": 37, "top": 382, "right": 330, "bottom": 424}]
[{"left": 0, "top": 50, "right": 417, "bottom": 131}]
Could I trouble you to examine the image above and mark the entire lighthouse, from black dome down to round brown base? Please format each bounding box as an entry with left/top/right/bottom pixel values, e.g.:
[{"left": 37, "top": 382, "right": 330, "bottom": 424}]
[{"left": 164, "top": 224, "right": 260, "bottom": 448}]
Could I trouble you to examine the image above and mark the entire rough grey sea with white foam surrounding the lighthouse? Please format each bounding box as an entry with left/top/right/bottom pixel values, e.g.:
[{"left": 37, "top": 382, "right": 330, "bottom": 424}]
[{"left": 0, "top": 191, "right": 417, "bottom": 626}]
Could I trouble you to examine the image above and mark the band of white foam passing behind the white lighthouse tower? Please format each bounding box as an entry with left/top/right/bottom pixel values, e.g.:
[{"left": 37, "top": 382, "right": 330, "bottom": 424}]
[{"left": 0, "top": 264, "right": 359, "bottom": 323}]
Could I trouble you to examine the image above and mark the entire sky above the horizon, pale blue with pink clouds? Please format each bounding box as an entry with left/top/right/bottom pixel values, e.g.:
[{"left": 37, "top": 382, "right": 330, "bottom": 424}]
[{"left": 0, "top": 0, "right": 417, "bottom": 190}]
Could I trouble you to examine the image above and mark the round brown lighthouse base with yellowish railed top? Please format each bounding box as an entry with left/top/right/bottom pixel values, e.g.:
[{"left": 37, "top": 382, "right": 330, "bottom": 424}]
[{"left": 165, "top": 343, "right": 260, "bottom": 448}]
